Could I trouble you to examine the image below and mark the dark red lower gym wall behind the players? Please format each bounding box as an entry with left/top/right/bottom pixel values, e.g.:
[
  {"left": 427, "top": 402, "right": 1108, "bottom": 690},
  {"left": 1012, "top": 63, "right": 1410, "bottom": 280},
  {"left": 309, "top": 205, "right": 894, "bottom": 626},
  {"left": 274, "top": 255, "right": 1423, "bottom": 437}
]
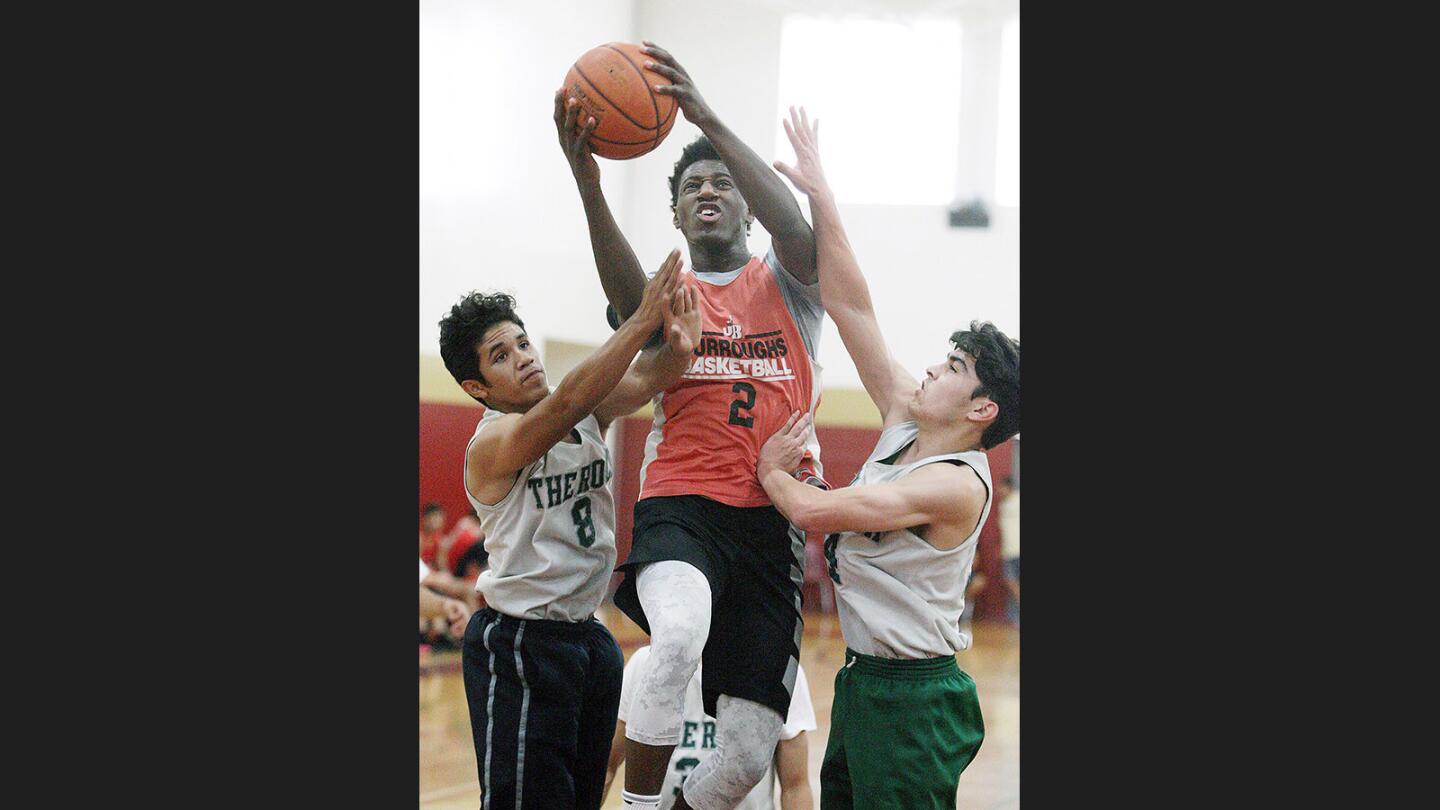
[{"left": 416, "top": 402, "right": 1014, "bottom": 618}]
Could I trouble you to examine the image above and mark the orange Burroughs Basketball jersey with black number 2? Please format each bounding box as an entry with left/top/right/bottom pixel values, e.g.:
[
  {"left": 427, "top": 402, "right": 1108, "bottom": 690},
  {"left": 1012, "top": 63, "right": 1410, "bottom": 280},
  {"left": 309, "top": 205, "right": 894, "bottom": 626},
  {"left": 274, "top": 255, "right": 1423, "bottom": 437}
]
[{"left": 639, "top": 252, "right": 822, "bottom": 506}]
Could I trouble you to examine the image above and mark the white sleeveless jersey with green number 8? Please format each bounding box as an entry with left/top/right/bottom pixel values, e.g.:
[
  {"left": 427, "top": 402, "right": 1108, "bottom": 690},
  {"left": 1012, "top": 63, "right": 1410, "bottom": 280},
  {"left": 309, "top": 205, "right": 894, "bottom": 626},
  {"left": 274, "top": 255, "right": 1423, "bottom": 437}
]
[{"left": 462, "top": 409, "right": 615, "bottom": 621}]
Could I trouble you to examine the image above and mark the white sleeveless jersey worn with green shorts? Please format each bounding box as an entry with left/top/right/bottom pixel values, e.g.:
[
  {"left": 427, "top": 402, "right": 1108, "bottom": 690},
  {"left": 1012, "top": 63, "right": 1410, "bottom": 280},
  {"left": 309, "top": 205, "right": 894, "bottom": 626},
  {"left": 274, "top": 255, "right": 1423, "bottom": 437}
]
[{"left": 825, "top": 421, "right": 992, "bottom": 659}]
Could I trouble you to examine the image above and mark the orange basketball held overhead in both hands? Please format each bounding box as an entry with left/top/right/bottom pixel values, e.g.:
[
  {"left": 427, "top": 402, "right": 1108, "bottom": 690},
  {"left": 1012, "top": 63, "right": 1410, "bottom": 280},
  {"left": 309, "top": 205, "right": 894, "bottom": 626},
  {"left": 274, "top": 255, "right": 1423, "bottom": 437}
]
[{"left": 564, "top": 42, "right": 677, "bottom": 160}]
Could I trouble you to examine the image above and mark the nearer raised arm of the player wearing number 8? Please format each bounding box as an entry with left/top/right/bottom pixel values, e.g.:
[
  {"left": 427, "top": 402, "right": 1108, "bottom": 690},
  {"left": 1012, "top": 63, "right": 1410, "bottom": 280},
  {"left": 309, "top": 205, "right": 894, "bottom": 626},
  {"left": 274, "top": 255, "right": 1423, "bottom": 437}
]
[{"left": 465, "top": 251, "right": 680, "bottom": 489}]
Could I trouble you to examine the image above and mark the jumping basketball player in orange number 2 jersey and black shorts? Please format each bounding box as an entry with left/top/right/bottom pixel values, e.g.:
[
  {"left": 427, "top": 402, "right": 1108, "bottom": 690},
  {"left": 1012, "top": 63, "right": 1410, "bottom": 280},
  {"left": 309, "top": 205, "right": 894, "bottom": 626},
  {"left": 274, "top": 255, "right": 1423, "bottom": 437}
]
[{"left": 554, "top": 42, "right": 824, "bottom": 810}]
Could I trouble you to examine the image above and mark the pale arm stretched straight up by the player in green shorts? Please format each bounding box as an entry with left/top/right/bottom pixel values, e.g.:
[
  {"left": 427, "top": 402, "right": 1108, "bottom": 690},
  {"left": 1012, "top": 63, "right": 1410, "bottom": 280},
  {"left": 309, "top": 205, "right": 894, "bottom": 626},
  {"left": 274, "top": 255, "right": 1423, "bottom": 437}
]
[{"left": 775, "top": 107, "right": 919, "bottom": 427}]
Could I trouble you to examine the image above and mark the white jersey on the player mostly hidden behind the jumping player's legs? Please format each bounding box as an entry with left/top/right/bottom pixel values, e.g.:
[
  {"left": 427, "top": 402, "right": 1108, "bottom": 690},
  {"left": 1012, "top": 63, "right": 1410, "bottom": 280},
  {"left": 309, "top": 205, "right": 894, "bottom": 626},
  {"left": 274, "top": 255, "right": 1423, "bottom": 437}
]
[{"left": 619, "top": 646, "right": 815, "bottom": 810}]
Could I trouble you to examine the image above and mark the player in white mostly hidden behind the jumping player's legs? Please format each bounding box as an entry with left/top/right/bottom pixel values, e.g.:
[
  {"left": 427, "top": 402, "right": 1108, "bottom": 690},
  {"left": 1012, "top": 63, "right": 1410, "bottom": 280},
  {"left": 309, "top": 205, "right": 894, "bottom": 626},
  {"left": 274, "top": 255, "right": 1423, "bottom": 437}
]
[{"left": 602, "top": 646, "right": 815, "bottom": 810}]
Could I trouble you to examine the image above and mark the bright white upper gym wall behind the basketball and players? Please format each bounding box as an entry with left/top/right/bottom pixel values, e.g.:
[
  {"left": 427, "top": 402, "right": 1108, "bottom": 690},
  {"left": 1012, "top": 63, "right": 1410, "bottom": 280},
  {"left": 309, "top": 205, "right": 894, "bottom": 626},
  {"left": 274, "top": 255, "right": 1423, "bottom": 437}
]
[{"left": 419, "top": 0, "right": 1020, "bottom": 388}]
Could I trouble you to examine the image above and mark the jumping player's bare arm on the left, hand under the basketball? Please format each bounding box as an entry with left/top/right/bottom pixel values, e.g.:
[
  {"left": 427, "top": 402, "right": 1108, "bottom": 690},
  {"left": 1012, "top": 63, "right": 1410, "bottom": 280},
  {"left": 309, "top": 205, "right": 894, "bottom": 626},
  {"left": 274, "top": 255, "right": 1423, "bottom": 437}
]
[{"left": 554, "top": 88, "right": 645, "bottom": 320}]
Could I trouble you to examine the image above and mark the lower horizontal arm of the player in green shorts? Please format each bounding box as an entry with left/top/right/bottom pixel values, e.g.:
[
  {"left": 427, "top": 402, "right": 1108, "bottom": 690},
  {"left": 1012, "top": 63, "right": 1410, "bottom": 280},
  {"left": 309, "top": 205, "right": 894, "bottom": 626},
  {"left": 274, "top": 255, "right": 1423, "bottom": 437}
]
[{"left": 760, "top": 463, "right": 985, "bottom": 536}]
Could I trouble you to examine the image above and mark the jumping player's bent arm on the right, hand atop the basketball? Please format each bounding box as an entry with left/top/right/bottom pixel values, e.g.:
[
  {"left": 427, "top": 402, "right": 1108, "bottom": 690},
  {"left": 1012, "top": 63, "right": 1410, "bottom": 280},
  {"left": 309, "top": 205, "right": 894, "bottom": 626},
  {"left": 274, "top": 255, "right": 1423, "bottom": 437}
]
[{"left": 641, "top": 40, "right": 815, "bottom": 284}]
